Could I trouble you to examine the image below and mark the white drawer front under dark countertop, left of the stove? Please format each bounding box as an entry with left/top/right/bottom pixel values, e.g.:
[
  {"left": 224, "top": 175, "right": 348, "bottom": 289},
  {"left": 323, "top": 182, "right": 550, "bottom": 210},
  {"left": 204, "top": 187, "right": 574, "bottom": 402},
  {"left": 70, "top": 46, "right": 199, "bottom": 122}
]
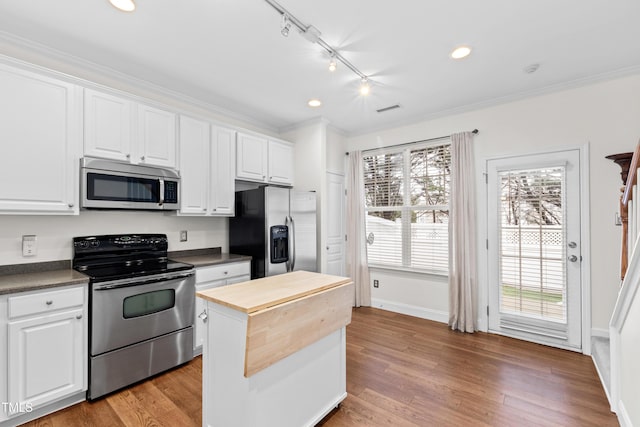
[{"left": 9, "top": 287, "right": 84, "bottom": 319}]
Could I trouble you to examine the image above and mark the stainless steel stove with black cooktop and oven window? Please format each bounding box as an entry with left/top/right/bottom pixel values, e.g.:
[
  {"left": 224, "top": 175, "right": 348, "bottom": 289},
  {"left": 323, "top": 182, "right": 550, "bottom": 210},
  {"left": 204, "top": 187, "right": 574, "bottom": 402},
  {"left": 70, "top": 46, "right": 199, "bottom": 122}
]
[{"left": 73, "top": 234, "right": 195, "bottom": 399}]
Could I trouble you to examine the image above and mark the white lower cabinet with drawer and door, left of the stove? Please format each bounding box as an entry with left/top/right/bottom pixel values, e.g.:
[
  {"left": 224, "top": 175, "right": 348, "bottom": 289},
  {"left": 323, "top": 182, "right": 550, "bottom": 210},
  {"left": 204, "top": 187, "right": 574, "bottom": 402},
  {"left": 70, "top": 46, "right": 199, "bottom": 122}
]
[{"left": 0, "top": 285, "right": 88, "bottom": 420}]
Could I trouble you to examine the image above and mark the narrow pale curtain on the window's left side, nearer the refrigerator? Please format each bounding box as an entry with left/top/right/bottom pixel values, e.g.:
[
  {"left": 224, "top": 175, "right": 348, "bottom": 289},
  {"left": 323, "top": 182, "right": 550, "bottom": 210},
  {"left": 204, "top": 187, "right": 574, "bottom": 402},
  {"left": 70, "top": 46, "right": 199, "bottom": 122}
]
[{"left": 347, "top": 151, "right": 371, "bottom": 307}]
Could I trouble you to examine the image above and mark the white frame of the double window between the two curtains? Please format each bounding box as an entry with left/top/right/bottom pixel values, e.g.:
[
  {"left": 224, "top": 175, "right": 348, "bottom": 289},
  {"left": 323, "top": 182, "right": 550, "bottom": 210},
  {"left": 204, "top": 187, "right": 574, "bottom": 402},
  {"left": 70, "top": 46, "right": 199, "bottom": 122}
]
[{"left": 361, "top": 137, "right": 451, "bottom": 277}]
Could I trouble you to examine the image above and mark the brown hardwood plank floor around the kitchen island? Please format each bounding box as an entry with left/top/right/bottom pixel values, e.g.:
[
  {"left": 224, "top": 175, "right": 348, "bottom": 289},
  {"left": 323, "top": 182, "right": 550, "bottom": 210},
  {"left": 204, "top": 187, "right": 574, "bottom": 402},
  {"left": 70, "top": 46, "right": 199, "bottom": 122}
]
[{"left": 27, "top": 308, "right": 618, "bottom": 427}]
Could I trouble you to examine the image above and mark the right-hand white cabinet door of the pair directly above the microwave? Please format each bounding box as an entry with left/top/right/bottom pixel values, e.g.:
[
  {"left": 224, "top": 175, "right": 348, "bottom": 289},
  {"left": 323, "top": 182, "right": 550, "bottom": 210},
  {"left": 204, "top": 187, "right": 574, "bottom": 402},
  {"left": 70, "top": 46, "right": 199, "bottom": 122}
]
[{"left": 135, "top": 105, "right": 177, "bottom": 168}]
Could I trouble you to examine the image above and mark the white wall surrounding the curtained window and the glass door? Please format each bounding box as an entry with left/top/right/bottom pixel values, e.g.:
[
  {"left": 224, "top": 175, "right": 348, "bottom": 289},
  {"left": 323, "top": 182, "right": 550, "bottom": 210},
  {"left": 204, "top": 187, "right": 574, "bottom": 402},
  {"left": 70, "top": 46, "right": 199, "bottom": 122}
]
[{"left": 347, "top": 75, "right": 640, "bottom": 334}]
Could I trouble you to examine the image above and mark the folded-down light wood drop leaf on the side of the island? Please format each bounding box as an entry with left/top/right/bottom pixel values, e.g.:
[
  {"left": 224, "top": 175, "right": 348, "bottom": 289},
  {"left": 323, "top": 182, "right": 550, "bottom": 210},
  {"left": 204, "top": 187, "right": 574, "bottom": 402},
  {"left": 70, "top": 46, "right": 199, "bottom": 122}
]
[{"left": 244, "top": 283, "right": 353, "bottom": 377}]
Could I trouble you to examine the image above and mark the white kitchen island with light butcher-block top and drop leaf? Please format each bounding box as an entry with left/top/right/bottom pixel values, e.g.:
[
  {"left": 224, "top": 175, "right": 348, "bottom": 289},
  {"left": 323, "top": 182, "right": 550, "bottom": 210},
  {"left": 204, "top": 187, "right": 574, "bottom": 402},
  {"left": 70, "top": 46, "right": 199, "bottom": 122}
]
[{"left": 196, "top": 271, "right": 354, "bottom": 427}]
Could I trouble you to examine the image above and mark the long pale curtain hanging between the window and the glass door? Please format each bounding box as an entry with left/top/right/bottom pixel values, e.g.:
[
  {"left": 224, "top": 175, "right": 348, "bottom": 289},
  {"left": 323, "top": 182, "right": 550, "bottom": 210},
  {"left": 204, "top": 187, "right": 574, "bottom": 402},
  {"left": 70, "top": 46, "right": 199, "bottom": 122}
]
[{"left": 449, "top": 132, "right": 477, "bottom": 332}]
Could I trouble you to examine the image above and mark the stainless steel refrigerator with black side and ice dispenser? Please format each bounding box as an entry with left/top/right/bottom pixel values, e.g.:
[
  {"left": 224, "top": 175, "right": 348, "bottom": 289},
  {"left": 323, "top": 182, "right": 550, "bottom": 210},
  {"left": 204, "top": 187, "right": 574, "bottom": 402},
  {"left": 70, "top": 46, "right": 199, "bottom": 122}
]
[{"left": 229, "top": 186, "right": 317, "bottom": 279}]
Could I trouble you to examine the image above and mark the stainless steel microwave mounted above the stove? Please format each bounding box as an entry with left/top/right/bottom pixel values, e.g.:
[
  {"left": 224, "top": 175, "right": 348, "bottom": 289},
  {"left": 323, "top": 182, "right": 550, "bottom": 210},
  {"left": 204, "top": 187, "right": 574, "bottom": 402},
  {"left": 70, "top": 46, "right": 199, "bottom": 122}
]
[{"left": 80, "top": 157, "right": 180, "bottom": 210}]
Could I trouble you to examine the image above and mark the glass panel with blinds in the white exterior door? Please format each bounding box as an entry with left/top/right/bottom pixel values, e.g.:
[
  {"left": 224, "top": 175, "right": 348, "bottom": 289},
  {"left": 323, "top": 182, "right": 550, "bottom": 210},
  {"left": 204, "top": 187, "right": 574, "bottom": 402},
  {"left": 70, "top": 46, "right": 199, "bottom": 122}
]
[{"left": 498, "top": 166, "right": 567, "bottom": 323}]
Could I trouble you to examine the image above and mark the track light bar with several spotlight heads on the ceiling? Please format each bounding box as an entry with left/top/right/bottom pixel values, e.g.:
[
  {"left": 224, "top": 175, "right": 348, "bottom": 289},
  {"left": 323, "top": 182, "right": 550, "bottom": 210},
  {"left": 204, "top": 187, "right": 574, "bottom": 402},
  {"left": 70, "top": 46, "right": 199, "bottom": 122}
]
[{"left": 264, "top": 0, "right": 371, "bottom": 95}]
